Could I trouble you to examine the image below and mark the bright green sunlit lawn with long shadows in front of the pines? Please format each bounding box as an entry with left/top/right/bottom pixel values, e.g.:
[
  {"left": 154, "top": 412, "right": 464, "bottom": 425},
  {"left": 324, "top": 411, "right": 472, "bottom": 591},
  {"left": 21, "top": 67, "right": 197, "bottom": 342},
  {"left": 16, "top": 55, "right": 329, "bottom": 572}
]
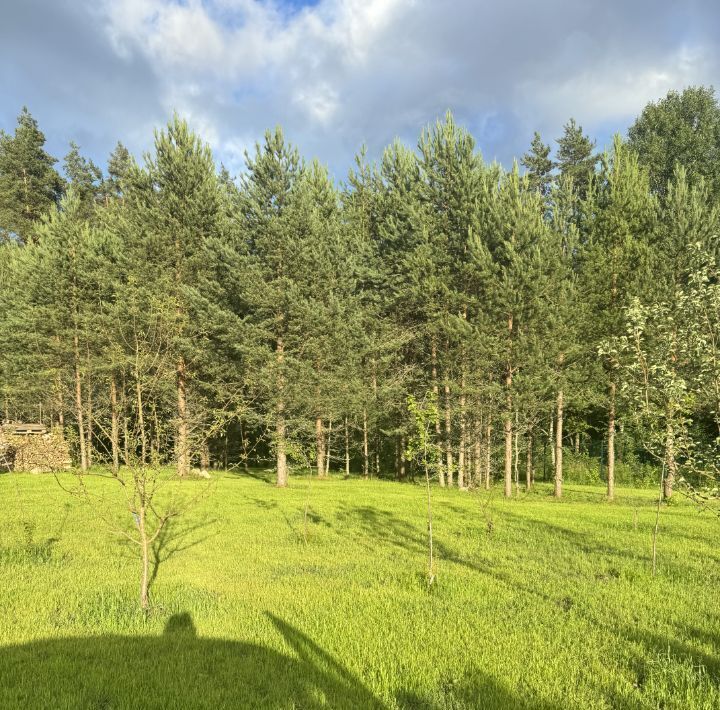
[{"left": 0, "top": 473, "right": 720, "bottom": 709}]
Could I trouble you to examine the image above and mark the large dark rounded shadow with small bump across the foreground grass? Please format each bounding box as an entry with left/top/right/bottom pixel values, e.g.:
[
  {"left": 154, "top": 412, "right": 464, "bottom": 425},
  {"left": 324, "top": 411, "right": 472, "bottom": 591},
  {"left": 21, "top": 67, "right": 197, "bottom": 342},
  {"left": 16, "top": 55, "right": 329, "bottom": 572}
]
[{"left": 0, "top": 614, "right": 384, "bottom": 709}]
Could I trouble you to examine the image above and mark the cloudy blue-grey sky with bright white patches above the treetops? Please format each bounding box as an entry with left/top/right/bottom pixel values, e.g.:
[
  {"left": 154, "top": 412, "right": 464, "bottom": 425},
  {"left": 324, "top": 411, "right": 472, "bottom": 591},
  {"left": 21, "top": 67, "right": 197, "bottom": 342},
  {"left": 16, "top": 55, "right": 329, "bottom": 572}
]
[{"left": 0, "top": 0, "right": 720, "bottom": 179}]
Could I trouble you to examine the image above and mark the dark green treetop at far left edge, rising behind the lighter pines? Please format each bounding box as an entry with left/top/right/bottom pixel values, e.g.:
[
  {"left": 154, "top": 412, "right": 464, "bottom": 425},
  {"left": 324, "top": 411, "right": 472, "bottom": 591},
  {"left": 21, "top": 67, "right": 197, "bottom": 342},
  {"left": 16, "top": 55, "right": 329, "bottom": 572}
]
[{"left": 0, "top": 108, "right": 62, "bottom": 243}]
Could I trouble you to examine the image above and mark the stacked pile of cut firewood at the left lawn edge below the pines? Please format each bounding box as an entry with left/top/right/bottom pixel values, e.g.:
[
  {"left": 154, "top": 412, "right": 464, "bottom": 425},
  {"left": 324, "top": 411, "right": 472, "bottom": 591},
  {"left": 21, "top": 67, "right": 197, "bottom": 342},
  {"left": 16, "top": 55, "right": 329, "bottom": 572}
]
[{"left": 0, "top": 424, "right": 72, "bottom": 473}]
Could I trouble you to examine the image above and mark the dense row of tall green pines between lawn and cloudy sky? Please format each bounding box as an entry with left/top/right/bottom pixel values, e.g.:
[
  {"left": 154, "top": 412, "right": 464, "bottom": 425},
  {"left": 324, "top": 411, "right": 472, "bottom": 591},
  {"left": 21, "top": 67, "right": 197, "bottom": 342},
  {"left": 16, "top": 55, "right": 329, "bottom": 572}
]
[{"left": 0, "top": 88, "right": 720, "bottom": 498}]
